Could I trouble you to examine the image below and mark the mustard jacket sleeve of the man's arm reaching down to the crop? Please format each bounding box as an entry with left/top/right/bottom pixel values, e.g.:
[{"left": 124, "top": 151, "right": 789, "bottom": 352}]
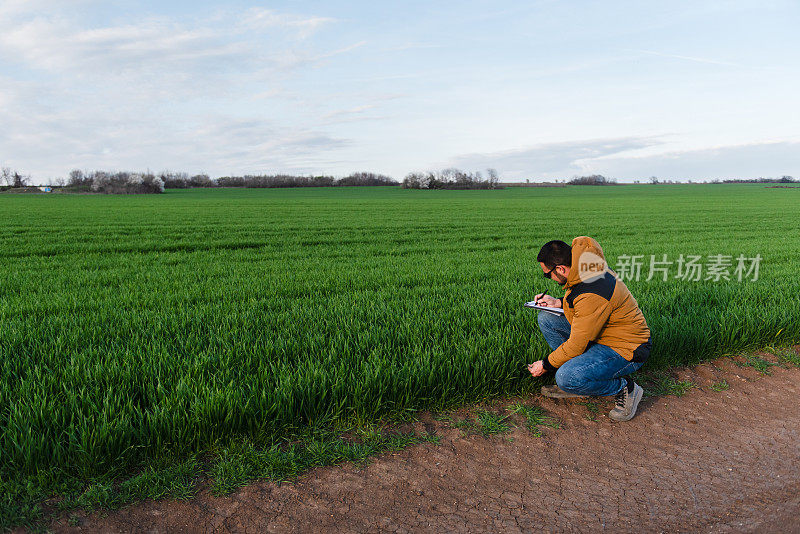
[{"left": 544, "top": 293, "right": 611, "bottom": 368}]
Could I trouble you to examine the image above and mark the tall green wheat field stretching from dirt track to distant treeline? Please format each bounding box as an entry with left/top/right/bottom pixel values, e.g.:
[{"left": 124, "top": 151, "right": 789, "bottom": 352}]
[{"left": 0, "top": 184, "right": 800, "bottom": 524}]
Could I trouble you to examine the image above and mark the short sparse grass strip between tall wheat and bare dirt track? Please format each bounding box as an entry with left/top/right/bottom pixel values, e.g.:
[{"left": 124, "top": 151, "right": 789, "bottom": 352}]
[{"left": 0, "top": 343, "right": 800, "bottom": 531}]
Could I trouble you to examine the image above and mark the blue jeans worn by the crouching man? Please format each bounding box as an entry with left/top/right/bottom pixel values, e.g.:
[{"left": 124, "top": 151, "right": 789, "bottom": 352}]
[{"left": 538, "top": 311, "right": 644, "bottom": 396}]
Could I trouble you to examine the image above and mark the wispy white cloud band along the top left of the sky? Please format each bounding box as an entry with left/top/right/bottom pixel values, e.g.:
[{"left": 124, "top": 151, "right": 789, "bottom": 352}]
[{"left": 0, "top": 5, "right": 342, "bottom": 78}]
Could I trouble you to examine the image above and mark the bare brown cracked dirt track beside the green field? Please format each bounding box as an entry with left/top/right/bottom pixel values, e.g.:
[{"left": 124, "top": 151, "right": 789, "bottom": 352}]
[{"left": 50, "top": 356, "right": 800, "bottom": 534}]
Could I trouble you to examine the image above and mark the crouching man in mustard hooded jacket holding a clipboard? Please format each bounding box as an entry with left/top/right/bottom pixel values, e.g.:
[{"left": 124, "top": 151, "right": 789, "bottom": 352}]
[{"left": 528, "top": 236, "right": 651, "bottom": 421}]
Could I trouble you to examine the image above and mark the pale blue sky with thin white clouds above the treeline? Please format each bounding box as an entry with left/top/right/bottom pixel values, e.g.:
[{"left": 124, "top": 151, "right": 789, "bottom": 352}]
[{"left": 0, "top": 0, "right": 800, "bottom": 183}]
